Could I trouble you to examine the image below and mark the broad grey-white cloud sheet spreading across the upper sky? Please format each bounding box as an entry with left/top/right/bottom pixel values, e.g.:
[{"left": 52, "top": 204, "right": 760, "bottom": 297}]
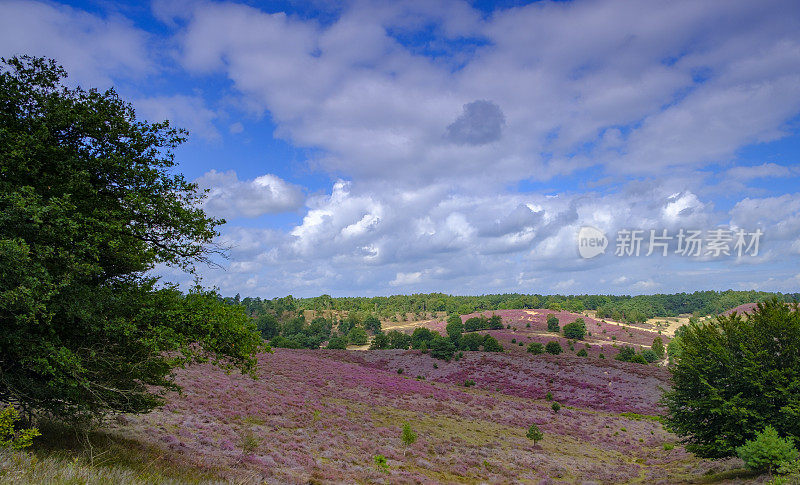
[{"left": 162, "top": 0, "right": 800, "bottom": 187}]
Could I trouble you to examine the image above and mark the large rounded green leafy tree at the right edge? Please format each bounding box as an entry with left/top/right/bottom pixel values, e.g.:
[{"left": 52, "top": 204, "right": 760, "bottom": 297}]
[{"left": 664, "top": 299, "right": 800, "bottom": 457}]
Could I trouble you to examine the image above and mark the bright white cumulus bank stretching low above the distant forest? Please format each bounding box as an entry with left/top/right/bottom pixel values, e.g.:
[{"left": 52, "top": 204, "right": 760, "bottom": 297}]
[{"left": 180, "top": 174, "right": 800, "bottom": 294}]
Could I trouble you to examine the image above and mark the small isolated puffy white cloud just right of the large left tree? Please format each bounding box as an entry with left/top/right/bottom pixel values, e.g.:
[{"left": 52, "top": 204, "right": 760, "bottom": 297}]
[{"left": 195, "top": 170, "right": 304, "bottom": 218}]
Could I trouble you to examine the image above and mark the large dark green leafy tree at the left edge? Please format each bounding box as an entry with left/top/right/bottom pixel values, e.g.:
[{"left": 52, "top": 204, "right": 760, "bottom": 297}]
[{"left": 0, "top": 57, "right": 261, "bottom": 419}]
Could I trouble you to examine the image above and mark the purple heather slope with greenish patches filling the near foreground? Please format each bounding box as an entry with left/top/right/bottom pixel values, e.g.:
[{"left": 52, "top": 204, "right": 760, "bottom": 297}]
[{"left": 79, "top": 349, "right": 752, "bottom": 484}]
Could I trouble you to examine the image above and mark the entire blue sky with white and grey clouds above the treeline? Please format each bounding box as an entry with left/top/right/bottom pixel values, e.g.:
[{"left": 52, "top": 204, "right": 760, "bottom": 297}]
[{"left": 0, "top": 0, "right": 800, "bottom": 297}]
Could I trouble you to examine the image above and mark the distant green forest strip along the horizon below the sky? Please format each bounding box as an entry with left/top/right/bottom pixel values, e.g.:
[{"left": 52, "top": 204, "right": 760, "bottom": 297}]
[{"left": 224, "top": 290, "right": 800, "bottom": 323}]
